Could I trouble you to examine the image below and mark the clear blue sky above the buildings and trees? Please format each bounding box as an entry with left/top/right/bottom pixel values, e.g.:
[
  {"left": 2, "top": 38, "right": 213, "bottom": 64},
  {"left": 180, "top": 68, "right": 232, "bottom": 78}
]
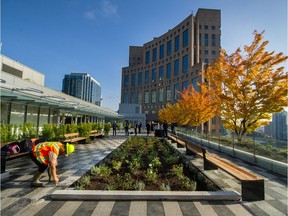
[{"left": 0, "top": 0, "right": 287, "bottom": 110}]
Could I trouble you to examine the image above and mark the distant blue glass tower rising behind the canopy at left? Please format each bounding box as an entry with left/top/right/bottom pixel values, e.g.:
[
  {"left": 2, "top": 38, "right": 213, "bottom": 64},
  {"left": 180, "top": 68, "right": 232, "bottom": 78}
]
[{"left": 62, "top": 73, "right": 101, "bottom": 106}]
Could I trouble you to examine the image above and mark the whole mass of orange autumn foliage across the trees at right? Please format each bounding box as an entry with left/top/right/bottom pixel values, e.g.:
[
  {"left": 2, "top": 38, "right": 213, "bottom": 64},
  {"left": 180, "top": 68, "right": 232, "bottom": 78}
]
[{"left": 159, "top": 31, "right": 288, "bottom": 140}]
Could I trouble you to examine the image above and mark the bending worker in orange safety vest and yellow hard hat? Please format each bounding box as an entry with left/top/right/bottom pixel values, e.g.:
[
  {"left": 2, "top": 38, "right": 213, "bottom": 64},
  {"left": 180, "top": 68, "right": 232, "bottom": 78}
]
[{"left": 30, "top": 142, "right": 74, "bottom": 187}]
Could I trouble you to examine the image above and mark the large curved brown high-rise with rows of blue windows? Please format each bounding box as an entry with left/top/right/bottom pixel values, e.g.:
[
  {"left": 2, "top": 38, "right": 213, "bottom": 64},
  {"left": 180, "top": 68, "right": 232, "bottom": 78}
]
[{"left": 121, "top": 9, "right": 221, "bottom": 132}]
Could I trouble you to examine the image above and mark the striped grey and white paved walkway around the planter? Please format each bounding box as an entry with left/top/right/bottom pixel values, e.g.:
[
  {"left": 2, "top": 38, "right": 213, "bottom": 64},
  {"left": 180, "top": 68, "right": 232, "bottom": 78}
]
[{"left": 1, "top": 135, "right": 287, "bottom": 216}]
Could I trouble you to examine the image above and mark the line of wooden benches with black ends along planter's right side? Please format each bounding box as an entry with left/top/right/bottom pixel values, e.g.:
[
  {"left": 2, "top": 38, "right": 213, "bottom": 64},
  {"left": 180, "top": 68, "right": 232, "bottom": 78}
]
[{"left": 169, "top": 132, "right": 265, "bottom": 201}]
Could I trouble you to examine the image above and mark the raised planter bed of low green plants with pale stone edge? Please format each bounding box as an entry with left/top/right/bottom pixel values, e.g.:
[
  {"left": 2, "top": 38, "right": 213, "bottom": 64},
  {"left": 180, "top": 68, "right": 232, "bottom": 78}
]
[{"left": 51, "top": 137, "right": 241, "bottom": 200}]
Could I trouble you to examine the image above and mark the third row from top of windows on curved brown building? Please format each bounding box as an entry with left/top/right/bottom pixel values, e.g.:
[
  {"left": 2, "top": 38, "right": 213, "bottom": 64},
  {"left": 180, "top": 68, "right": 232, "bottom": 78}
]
[{"left": 122, "top": 77, "right": 199, "bottom": 104}]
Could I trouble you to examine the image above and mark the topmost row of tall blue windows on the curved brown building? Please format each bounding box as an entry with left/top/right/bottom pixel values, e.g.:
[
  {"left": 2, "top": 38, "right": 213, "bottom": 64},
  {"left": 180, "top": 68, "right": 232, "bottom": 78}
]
[{"left": 145, "top": 29, "right": 189, "bottom": 64}]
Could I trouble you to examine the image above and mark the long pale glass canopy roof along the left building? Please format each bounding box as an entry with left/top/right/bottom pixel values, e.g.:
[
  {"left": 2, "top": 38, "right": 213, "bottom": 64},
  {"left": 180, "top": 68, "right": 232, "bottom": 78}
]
[{"left": 0, "top": 71, "right": 122, "bottom": 119}]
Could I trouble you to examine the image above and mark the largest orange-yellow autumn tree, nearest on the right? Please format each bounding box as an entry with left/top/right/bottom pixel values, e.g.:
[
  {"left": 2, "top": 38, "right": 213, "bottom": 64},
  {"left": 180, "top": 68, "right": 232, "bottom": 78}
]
[{"left": 202, "top": 31, "right": 288, "bottom": 141}]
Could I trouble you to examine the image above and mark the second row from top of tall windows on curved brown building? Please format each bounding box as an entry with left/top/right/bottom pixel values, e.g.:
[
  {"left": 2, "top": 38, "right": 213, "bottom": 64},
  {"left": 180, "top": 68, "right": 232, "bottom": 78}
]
[{"left": 124, "top": 55, "right": 189, "bottom": 87}]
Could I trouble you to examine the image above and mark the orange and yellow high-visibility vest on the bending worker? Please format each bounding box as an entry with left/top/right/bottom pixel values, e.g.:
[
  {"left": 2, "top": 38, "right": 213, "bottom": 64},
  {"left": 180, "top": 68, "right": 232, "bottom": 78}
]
[{"left": 32, "top": 142, "right": 62, "bottom": 165}]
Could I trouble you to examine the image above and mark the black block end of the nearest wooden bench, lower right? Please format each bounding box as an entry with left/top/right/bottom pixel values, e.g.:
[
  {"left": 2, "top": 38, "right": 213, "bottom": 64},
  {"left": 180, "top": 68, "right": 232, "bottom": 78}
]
[{"left": 241, "top": 179, "right": 265, "bottom": 201}]
